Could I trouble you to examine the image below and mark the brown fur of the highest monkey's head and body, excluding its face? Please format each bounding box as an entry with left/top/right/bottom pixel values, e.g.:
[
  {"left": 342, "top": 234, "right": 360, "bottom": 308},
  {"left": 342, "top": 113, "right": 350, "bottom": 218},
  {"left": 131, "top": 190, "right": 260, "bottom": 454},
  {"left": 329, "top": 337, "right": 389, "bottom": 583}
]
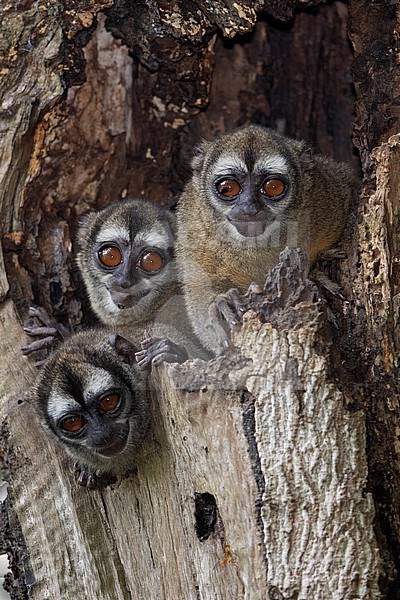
[{"left": 176, "top": 126, "right": 355, "bottom": 354}]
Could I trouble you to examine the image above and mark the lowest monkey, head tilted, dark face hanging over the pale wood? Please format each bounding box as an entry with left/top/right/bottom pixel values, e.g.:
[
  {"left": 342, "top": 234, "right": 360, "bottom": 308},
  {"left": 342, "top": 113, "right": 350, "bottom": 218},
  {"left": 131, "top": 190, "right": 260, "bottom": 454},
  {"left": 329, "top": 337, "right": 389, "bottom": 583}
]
[{"left": 33, "top": 329, "right": 150, "bottom": 488}]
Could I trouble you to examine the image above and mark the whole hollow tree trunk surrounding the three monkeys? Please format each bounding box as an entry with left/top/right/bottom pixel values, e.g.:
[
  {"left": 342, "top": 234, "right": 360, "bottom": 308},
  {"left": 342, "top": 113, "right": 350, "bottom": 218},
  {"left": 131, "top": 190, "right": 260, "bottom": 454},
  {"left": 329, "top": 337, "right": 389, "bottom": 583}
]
[{"left": 0, "top": 0, "right": 400, "bottom": 600}]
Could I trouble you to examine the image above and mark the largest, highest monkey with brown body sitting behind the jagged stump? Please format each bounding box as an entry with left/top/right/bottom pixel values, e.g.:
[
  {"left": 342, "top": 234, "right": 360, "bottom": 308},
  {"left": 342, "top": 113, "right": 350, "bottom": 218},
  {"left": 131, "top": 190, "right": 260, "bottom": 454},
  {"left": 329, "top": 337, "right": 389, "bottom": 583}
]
[{"left": 176, "top": 125, "right": 356, "bottom": 355}]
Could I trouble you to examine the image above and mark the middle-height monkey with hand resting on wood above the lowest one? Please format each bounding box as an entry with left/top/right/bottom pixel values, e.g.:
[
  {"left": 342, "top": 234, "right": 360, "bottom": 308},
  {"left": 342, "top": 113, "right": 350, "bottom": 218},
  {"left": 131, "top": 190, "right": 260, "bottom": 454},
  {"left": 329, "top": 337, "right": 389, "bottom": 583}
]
[{"left": 77, "top": 199, "right": 209, "bottom": 364}]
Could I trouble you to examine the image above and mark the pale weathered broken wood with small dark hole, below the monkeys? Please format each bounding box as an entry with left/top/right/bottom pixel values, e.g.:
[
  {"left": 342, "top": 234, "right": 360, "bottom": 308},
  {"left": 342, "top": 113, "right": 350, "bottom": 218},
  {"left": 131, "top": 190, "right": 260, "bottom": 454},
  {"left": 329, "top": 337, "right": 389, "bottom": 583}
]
[{"left": 1, "top": 255, "right": 379, "bottom": 600}]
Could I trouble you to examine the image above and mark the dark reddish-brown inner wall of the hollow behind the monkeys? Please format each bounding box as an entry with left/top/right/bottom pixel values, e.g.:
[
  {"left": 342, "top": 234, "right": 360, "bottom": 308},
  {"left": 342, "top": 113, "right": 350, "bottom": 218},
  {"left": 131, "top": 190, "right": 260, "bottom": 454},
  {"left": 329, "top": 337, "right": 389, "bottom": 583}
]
[{"left": 4, "top": 3, "right": 353, "bottom": 326}]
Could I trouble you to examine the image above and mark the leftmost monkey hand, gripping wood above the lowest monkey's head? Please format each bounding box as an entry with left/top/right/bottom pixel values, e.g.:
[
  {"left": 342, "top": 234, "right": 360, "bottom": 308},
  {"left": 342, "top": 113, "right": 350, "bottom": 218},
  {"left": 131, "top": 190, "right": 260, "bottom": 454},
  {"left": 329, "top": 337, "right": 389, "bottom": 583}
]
[{"left": 21, "top": 306, "right": 69, "bottom": 367}]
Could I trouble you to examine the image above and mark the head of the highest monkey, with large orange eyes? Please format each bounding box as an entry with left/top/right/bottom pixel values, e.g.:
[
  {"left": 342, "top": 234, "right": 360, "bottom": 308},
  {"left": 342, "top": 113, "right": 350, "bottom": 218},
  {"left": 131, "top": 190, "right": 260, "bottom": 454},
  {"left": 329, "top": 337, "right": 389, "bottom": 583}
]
[{"left": 193, "top": 126, "right": 298, "bottom": 238}]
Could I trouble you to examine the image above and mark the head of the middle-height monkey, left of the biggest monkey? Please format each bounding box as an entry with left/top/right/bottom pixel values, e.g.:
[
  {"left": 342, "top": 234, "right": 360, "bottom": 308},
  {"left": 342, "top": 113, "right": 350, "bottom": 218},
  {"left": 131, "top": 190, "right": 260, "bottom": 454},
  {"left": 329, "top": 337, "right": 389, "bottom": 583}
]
[{"left": 78, "top": 200, "right": 175, "bottom": 325}]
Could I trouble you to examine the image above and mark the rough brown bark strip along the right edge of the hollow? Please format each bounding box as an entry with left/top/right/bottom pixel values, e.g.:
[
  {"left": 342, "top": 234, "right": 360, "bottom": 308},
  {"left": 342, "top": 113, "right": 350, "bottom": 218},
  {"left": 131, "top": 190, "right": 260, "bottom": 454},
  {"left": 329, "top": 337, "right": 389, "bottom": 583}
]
[{"left": 337, "top": 135, "right": 400, "bottom": 598}]
